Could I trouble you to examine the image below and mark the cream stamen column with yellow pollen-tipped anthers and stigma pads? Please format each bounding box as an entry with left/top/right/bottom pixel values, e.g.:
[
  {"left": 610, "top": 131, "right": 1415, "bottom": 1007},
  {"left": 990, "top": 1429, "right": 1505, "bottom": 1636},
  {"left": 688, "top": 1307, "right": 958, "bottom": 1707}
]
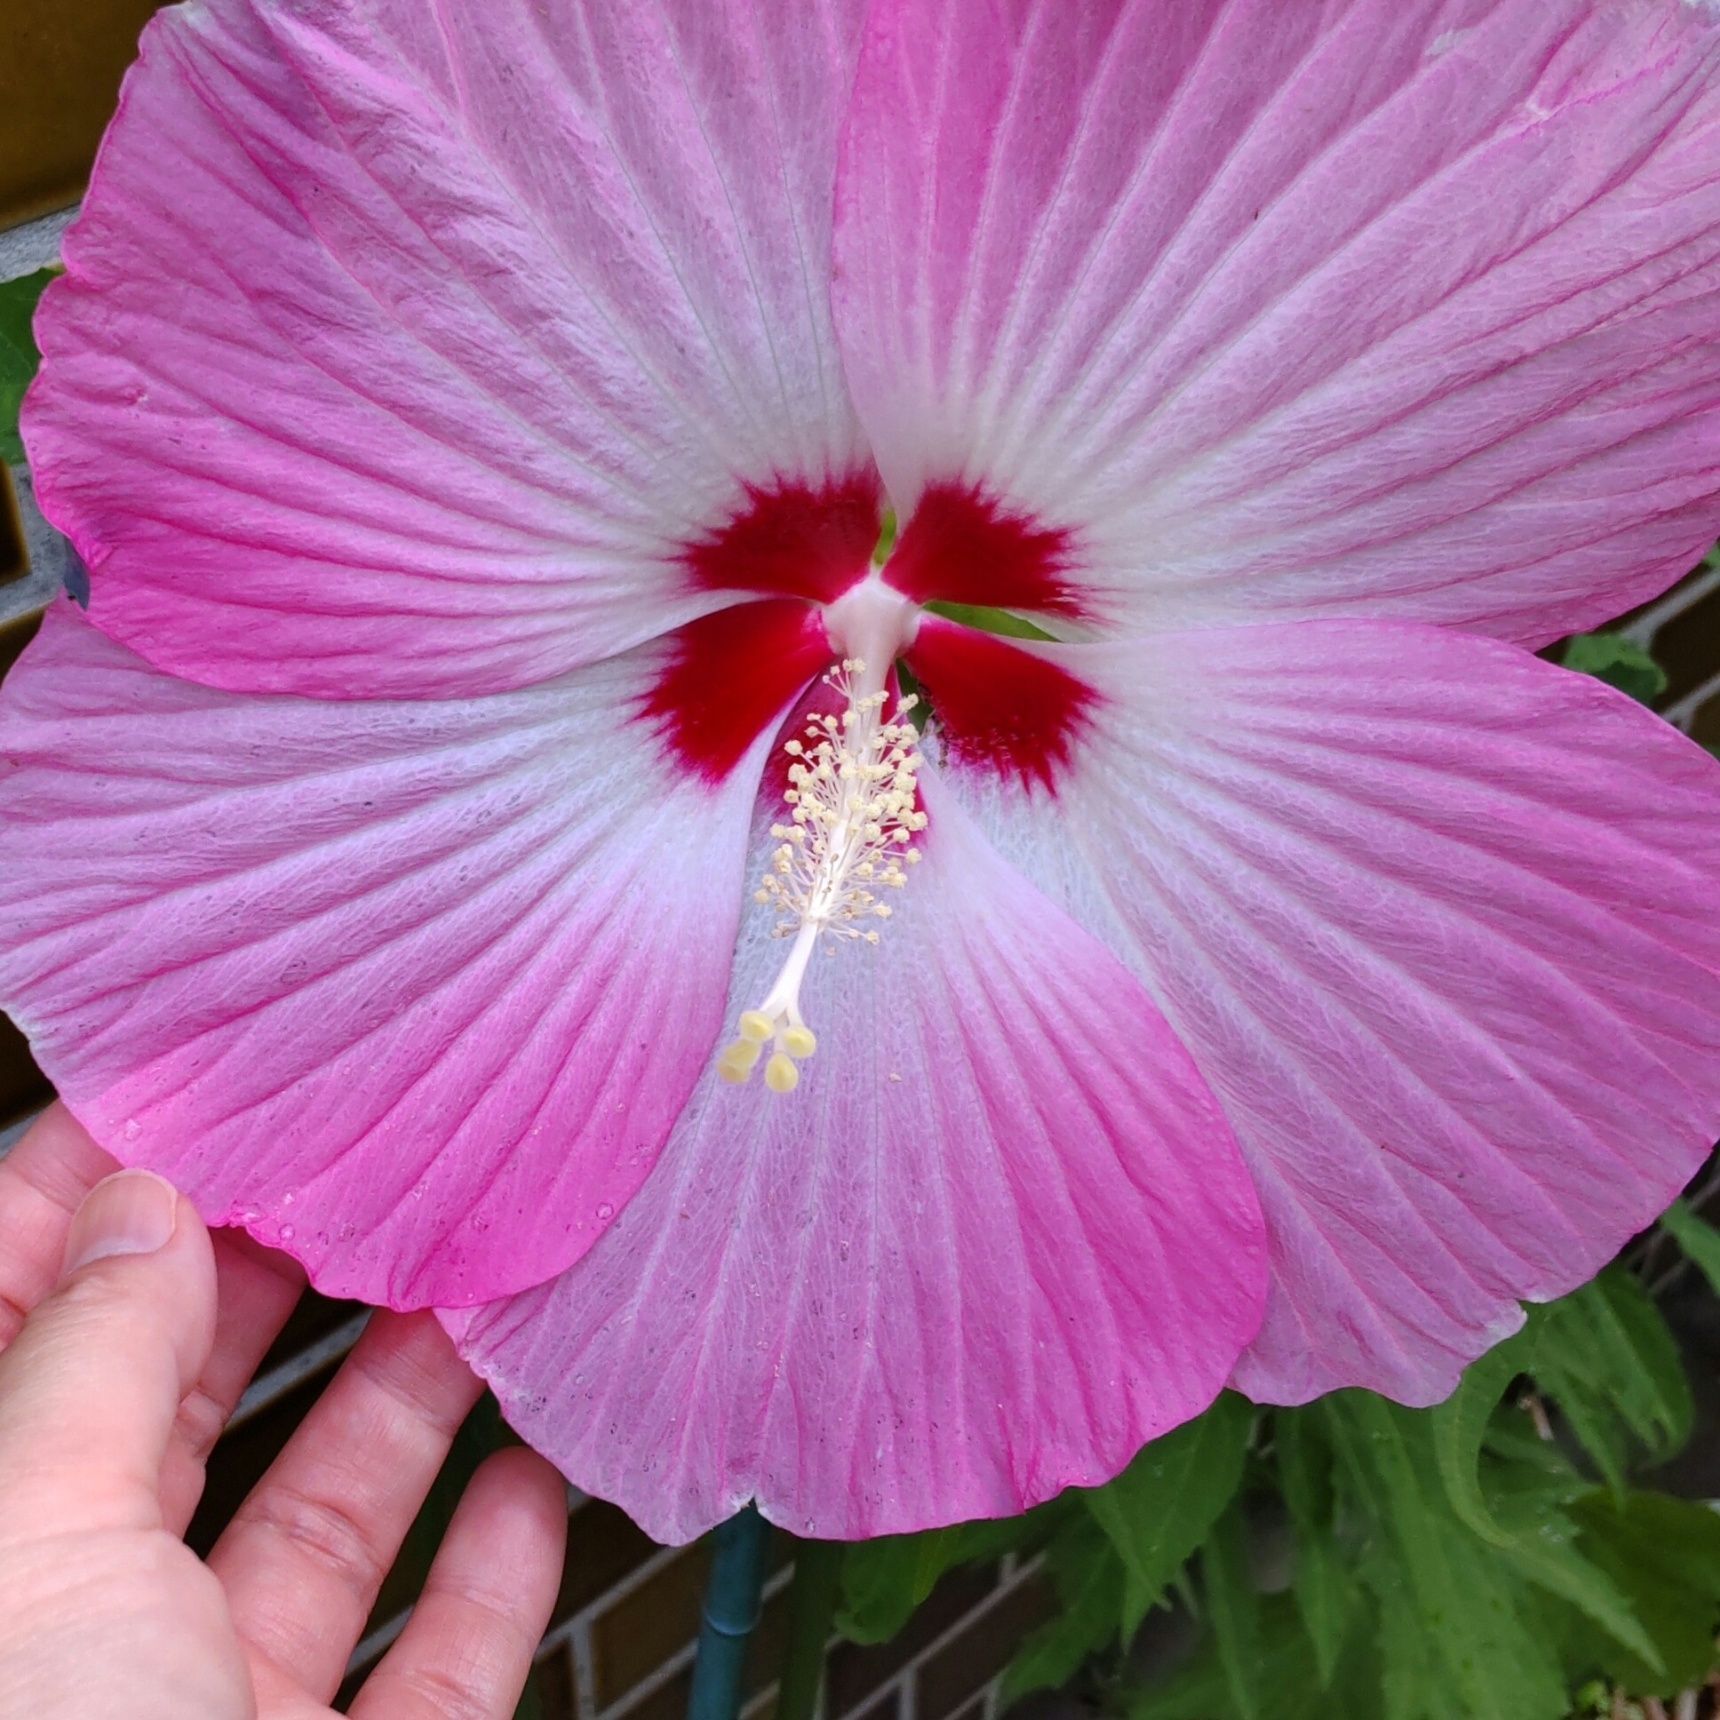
[{"left": 717, "top": 657, "right": 925, "bottom": 1092}]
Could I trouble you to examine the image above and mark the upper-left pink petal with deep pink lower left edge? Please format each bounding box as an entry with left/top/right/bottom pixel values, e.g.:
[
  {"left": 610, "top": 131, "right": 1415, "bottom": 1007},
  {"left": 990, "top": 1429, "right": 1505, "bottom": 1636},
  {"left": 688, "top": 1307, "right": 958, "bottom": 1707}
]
[{"left": 26, "top": 0, "right": 875, "bottom": 698}]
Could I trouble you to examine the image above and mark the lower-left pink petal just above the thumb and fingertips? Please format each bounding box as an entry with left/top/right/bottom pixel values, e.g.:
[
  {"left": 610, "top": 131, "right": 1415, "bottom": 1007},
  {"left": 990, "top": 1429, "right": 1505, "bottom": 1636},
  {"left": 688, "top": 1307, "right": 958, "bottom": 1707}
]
[{"left": 0, "top": 607, "right": 798, "bottom": 1305}]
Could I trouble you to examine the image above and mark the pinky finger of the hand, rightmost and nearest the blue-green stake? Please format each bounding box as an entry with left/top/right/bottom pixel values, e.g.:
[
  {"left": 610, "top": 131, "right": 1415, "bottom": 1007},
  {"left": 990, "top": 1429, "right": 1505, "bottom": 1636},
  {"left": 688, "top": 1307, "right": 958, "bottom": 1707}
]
[{"left": 351, "top": 1450, "right": 568, "bottom": 1720}]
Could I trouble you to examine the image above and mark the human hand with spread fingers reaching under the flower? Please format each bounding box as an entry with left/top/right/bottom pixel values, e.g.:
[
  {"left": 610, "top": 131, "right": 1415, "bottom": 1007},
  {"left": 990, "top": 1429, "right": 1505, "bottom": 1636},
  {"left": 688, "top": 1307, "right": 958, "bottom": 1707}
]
[{"left": 0, "top": 1108, "right": 568, "bottom": 1720}]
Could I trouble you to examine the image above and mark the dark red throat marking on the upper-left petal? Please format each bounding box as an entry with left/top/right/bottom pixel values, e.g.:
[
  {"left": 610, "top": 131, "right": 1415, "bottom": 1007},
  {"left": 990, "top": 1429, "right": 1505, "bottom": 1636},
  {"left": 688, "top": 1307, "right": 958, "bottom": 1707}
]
[{"left": 681, "top": 471, "right": 882, "bottom": 604}]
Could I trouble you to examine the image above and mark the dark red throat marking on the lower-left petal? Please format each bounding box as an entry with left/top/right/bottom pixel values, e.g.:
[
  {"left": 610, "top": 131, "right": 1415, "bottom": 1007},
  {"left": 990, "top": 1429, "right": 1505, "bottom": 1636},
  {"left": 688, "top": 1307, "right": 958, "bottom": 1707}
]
[{"left": 640, "top": 597, "right": 831, "bottom": 783}]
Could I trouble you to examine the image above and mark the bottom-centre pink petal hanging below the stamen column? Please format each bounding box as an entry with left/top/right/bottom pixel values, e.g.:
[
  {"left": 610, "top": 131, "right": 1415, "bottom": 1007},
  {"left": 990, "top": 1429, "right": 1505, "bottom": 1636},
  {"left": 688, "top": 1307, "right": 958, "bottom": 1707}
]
[{"left": 447, "top": 777, "right": 1264, "bottom": 1541}]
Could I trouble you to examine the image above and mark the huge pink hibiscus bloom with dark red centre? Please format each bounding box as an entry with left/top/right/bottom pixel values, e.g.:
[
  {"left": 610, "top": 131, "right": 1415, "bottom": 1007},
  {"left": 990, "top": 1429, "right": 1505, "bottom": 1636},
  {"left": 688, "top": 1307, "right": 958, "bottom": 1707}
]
[{"left": 0, "top": 0, "right": 1720, "bottom": 1538}]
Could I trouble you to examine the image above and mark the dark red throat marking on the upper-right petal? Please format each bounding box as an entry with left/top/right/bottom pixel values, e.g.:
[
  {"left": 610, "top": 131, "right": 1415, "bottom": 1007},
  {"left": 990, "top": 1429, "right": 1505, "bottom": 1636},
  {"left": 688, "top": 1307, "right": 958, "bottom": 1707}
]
[{"left": 884, "top": 483, "right": 1082, "bottom": 616}]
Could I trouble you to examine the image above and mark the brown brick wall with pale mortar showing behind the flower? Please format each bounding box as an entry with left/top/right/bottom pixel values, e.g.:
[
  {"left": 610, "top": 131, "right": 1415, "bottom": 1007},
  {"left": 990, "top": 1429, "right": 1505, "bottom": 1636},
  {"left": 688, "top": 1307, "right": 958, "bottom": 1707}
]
[{"left": 10, "top": 20, "right": 1720, "bottom": 1720}]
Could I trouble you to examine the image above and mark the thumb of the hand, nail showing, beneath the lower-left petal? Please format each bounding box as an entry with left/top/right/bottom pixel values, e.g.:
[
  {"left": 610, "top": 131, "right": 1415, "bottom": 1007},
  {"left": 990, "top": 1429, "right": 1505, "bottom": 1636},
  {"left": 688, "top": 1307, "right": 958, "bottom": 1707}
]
[{"left": 0, "top": 1171, "right": 215, "bottom": 1531}]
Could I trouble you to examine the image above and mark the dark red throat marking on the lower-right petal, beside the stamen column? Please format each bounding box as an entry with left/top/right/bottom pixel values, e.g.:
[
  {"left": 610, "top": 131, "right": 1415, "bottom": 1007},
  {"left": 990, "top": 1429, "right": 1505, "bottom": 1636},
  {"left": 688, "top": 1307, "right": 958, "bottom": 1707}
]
[{"left": 908, "top": 616, "right": 1099, "bottom": 795}]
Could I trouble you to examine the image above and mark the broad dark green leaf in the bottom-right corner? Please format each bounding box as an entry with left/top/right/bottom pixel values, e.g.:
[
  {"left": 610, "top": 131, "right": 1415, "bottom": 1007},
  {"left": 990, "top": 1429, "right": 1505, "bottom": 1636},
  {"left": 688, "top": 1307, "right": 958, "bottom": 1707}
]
[{"left": 1572, "top": 1491, "right": 1720, "bottom": 1696}]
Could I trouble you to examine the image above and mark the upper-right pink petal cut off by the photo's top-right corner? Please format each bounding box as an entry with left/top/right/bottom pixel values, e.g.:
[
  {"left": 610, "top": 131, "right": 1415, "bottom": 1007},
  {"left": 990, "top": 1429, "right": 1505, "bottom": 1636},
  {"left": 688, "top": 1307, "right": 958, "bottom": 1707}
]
[{"left": 836, "top": 0, "right": 1720, "bottom": 643}]
